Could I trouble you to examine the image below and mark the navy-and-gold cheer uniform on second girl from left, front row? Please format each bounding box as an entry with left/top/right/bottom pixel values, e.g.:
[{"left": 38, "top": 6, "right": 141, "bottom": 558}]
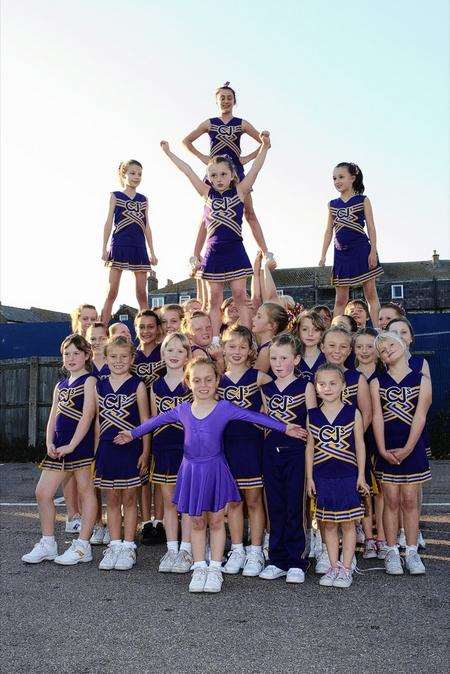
[{"left": 94, "top": 376, "right": 148, "bottom": 489}]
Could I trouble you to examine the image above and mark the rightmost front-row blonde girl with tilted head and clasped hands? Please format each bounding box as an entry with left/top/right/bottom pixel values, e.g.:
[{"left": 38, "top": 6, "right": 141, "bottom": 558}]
[{"left": 370, "top": 332, "right": 431, "bottom": 575}]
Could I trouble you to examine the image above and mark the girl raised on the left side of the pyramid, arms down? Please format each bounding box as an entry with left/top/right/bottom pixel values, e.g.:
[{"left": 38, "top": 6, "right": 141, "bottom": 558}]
[{"left": 102, "top": 159, "right": 158, "bottom": 325}]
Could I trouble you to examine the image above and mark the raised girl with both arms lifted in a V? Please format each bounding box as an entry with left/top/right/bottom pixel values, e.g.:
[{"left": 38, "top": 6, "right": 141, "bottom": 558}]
[{"left": 161, "top": 131, "right": 270, "bottom": 336}]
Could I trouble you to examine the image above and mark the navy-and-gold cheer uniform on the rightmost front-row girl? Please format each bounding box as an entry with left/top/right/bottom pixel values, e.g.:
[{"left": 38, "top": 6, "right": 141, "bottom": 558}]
[{"left": 377, "top": 372, "right": 431, "bottom": 484}]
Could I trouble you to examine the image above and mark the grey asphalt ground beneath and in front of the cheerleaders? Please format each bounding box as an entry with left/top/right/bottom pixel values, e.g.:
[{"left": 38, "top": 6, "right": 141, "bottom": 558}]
[{"left": 0, "top": 461, "right": 450, "bottom": 674}]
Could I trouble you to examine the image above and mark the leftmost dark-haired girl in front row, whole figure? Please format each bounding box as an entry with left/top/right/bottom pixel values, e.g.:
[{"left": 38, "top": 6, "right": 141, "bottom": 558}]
[{"left": 22, "top": 335, "right": 97, "bottom": 565}]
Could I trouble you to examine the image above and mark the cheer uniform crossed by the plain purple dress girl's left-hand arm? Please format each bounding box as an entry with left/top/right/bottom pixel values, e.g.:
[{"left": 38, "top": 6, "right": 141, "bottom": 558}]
[{"left": 150, "top": 377, "right": 192, "bottom": 484}]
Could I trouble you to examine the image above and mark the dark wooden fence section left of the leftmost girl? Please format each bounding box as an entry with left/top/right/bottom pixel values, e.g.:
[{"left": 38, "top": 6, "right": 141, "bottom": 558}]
[{"left": 0, "top": 356, "right": 61, "bottom": 448}]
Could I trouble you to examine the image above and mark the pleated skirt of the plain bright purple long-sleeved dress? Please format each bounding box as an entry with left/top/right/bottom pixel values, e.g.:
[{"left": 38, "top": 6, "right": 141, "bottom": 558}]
[{"left": 172, "top": 454, "right": 241, "bottom": 517}]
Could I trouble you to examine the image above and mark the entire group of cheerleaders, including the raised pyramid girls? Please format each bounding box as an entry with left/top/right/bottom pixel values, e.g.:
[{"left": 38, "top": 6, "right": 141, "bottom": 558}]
[{"left": 22, "top": 83, "right": 431, "bottom": 593}]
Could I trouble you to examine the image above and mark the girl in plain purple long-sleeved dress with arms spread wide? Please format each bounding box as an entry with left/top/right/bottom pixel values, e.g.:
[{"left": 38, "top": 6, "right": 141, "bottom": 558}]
[{"left": 116, "top": 357, "right": 300, "bottom": 592}]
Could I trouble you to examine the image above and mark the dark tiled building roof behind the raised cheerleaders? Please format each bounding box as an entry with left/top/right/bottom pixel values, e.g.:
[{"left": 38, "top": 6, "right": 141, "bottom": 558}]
[{"left": 152, "top": 260, "right": 450, "bottom": 295}]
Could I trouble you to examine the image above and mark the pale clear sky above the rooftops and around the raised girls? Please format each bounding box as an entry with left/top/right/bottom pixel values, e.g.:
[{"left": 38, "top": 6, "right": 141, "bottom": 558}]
[{"left": 1, "top": 0, "right": 450, "bottom": 311}]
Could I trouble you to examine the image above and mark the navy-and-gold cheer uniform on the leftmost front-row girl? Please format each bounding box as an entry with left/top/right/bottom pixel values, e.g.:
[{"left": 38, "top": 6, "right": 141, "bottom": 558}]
[{"left": 40, "top": 374, "right": 95, "bottom": 470}]
